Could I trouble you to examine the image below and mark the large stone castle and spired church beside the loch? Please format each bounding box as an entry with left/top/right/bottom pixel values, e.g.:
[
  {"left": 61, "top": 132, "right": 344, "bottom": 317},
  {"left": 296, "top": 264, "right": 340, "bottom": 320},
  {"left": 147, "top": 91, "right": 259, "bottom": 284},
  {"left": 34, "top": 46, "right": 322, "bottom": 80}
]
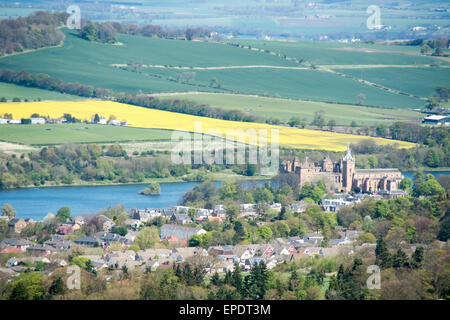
[{"left": 281, "top": 148, "right": 404, "bottom": 193}]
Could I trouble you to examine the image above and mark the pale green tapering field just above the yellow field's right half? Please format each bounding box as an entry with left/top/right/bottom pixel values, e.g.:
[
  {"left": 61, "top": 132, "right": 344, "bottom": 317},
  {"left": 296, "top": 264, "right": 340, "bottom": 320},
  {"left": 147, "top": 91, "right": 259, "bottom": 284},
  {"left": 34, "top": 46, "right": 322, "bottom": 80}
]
[{"left": 153, "top": 93, "right": 423, "bottom": 125}]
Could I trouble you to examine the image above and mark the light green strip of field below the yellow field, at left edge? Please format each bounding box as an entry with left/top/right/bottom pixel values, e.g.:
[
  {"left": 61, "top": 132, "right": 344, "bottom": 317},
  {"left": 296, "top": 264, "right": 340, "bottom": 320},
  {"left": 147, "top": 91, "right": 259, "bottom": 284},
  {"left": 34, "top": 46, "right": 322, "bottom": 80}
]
[{"left": 0, "top": 124, "right": 172, "bottom": 145}]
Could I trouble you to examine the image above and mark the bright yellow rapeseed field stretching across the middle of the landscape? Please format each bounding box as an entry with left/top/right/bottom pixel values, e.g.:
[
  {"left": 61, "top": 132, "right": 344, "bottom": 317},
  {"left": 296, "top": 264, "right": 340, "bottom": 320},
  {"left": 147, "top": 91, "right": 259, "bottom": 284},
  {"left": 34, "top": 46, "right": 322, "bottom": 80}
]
[{"left": 0, "top": 100, "right": 414, "bottom": 151}]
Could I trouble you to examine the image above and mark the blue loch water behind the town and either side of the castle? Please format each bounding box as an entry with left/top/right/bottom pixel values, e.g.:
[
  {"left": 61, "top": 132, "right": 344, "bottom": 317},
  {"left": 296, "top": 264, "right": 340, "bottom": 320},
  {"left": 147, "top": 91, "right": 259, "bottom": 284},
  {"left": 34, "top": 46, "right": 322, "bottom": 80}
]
[{"left": 0, "top": 171, "right": 450, "bottom": 220}]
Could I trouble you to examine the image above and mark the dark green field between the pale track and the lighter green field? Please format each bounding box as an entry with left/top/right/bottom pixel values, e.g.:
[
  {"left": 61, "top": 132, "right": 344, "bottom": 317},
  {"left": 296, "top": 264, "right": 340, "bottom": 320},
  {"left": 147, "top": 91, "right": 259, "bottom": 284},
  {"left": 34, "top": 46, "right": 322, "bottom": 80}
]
[{"left": 149, "top": 68, "right": 425, "bottom": 108}]
